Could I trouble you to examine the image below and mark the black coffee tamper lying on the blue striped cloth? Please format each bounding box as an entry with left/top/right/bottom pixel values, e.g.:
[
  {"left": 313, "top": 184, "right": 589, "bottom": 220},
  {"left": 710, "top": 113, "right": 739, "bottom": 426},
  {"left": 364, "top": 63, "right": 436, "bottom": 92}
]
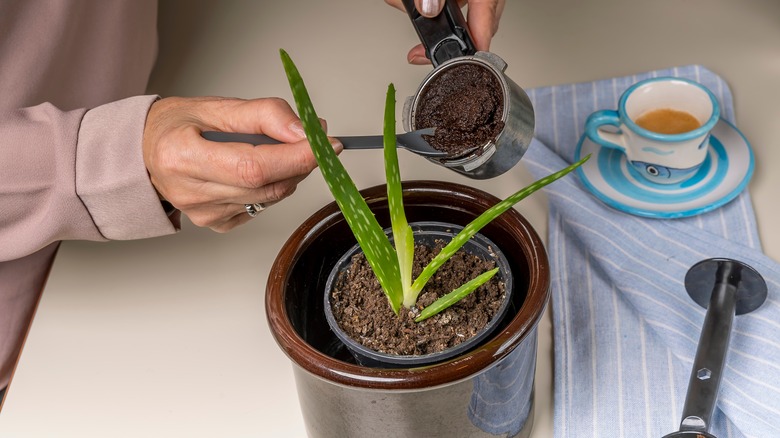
[{"left": 664, "top": 258, "right": 767, "bottom": 438}]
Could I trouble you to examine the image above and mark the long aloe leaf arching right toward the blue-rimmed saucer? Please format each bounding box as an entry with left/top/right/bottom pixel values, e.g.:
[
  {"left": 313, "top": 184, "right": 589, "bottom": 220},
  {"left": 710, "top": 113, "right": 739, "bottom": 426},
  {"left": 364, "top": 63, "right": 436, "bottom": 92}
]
[{"left": 412, "top": 155, "right": 590, "bottom": 300}]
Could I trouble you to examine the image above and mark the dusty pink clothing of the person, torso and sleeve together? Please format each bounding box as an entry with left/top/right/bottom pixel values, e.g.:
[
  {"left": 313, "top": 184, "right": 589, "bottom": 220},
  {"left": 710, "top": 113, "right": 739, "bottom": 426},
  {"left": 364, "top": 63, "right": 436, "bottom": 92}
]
[{"left": 0, "top": 0, "right": 168, "bottom": 388}]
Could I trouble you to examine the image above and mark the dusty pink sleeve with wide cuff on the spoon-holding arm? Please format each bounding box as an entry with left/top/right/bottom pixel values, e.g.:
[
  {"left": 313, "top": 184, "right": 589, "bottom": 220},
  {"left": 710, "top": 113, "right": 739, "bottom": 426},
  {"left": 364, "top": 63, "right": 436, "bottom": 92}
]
[{"left": 0, "top": 96, "right": 177, "bottom": 261}]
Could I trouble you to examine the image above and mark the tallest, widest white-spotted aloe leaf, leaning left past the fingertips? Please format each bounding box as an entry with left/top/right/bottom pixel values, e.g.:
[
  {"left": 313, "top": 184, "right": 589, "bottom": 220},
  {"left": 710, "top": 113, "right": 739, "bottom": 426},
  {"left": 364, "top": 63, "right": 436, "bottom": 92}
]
[{"left": 279, "top": 50, "right": 403, "bottom": 313}]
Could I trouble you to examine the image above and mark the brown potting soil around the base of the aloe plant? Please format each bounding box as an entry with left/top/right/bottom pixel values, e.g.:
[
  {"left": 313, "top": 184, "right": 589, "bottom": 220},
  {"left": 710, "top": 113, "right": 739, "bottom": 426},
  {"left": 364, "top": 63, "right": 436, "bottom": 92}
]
[{"left": 331, "top": 244, "right": 505, "bottom": 355}]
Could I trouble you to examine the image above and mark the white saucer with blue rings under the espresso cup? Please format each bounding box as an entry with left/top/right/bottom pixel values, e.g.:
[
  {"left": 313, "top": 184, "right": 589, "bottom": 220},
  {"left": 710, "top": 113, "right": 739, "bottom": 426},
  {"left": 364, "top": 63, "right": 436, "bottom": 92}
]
[{"left": 574, "top": 119, "right": 754, "bottom": 218}]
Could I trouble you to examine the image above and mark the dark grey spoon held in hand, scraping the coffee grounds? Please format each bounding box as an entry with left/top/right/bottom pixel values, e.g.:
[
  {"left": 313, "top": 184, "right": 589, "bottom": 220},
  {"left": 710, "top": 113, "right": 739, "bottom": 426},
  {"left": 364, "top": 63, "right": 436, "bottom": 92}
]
[{"left": 201, "top": 128, "right": 447, "bottom": 158}]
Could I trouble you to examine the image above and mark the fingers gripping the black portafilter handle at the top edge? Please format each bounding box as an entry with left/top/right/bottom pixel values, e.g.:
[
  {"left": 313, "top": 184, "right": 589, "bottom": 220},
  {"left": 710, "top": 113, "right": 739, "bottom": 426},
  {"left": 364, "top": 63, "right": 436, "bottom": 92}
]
[{"left": 385, "top": 0, "right": 506, "bottom": 65}]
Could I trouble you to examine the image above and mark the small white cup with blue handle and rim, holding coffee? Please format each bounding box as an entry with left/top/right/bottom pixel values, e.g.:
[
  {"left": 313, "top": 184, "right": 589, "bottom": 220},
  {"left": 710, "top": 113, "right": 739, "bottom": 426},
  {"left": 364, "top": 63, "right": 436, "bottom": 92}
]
[{"left": 585, "top": 77, "right": 720, "bottom": 184}]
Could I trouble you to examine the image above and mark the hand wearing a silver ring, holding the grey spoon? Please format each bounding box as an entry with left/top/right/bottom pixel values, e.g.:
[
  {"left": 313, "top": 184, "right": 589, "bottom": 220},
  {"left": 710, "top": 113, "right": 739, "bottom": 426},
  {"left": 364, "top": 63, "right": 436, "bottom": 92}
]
[{"left": 143, "top": 97, "right": 341, "bottom": 232}]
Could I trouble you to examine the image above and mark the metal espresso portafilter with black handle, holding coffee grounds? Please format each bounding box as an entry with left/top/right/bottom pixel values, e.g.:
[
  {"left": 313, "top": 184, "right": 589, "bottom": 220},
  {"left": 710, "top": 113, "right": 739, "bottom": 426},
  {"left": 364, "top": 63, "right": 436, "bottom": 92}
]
[{"left": 403, "top": 0, "right": 534, "bottom": 179}]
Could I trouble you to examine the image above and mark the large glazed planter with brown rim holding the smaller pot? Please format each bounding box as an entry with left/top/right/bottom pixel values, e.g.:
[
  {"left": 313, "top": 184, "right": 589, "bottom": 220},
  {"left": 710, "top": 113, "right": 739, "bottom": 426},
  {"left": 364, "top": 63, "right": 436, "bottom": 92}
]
[{"left": 266, "top": 181, "right": 550, "bottom": 438}]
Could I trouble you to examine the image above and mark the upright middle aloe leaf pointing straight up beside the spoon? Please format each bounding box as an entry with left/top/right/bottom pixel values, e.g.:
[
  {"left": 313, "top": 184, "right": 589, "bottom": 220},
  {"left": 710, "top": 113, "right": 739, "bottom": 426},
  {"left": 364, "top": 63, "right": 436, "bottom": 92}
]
[{"left": 383, "top": 84, "right": 414, "bottom": 307}]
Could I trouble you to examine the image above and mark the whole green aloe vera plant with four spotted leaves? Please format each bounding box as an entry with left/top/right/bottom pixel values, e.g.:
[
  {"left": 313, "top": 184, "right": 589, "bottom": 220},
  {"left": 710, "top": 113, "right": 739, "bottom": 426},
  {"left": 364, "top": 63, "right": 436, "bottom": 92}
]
[{"left": 280, "top": 50, "right": 590, "bottom": 322}]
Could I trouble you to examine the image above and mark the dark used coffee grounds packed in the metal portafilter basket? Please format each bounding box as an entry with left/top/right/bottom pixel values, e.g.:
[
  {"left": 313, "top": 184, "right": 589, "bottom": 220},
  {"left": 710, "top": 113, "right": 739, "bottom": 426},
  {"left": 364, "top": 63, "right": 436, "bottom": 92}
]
[{"left": 414, "top": 64, "right": 504, "bottom": 157}]
